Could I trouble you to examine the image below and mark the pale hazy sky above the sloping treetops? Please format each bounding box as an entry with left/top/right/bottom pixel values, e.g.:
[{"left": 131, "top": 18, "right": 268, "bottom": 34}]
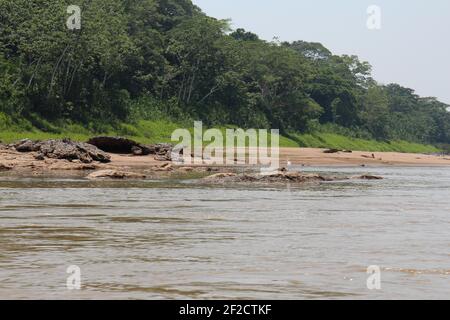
[{"left": 193, "top": 0, "right": 450, "bottom": 104}]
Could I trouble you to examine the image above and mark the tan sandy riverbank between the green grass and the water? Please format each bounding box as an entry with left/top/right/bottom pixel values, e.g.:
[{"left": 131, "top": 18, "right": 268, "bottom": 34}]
[{"left": 0, "top": 142, "right": 450, "bottom": 175}]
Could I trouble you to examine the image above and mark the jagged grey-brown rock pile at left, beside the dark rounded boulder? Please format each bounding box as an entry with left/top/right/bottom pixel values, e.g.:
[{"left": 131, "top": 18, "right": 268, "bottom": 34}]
[{"left": 14, "top": 139, "right": 111, "bottom": 163}]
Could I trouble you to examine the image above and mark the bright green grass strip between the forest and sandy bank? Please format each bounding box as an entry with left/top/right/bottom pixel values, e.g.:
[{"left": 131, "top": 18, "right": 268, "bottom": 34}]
[{"left": 0, "top": 120, "right": 440, "bottom": 153}]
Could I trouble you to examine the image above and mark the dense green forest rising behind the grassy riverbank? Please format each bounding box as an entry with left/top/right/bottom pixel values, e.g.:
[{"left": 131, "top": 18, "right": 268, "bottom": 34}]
[{"left": 0, "top": 0, "right": 450, "bottom": 143}]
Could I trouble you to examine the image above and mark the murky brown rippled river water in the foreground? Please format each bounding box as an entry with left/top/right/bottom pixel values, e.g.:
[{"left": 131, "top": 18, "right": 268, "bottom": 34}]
[{"left": 0, "top": 168, "right": 450, "bottom": 299}]
